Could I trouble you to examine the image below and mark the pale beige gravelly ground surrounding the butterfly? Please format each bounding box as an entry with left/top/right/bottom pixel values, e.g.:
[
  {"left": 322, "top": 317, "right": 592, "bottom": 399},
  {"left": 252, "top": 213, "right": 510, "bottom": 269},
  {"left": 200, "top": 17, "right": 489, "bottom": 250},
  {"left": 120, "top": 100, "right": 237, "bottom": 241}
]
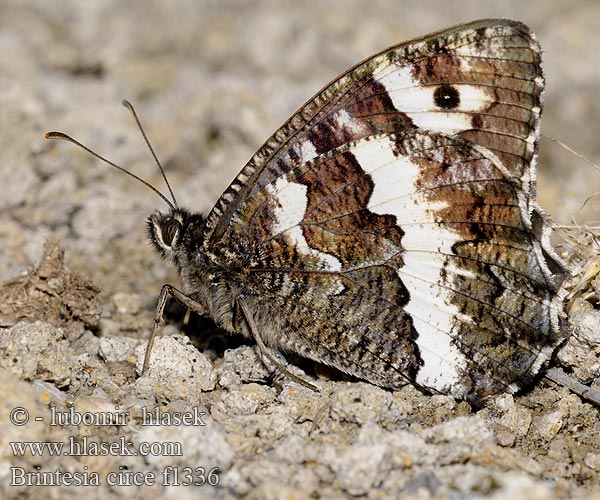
[{"left": 0, "top": 0, "right": 600, "bottom": 500}]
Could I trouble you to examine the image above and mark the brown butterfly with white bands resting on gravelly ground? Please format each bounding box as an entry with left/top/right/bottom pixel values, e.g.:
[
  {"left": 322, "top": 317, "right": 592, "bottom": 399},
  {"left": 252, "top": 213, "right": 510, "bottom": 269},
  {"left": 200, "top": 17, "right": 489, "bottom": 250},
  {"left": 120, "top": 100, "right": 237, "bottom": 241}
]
[{"left": 47, "top": 19, "right": 568, "bottom": 410}]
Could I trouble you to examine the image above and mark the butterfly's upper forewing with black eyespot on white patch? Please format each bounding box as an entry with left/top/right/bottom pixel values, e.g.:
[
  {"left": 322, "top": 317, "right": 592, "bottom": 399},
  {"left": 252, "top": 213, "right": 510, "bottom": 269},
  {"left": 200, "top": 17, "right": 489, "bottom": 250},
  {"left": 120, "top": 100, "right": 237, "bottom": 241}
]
[{"left": 206, "top": 20, "right": 543, "bottom": 241}]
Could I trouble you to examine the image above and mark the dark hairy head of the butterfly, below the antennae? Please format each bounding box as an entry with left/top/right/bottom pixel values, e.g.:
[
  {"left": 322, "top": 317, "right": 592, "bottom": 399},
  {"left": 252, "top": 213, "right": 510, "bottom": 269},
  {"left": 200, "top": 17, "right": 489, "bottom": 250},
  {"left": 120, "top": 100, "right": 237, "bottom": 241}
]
[{"left": 147, "top": 208, "right": 205, "bottom": 263}]
